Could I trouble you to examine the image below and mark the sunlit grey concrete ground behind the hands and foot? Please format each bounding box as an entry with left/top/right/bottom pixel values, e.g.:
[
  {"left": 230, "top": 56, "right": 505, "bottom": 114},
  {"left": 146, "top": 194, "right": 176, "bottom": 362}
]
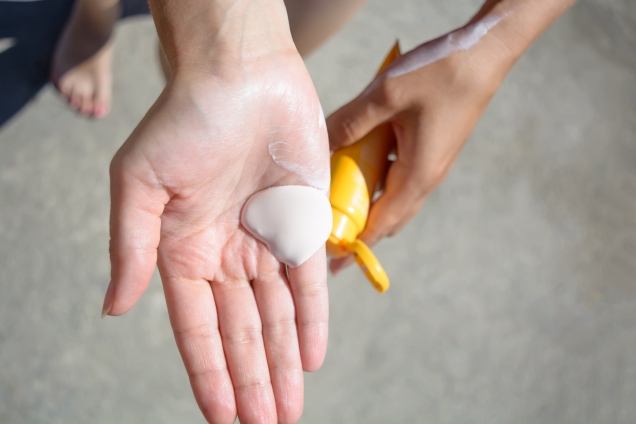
[{"left": 0, "top": 0, "right": 636, "bottom": 424}]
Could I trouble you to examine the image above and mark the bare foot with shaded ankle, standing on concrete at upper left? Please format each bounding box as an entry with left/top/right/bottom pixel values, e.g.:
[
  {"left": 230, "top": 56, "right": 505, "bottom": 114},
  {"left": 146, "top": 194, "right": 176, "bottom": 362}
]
[{"left": 51, "top": 0, "right": 118, "bottom": 118}]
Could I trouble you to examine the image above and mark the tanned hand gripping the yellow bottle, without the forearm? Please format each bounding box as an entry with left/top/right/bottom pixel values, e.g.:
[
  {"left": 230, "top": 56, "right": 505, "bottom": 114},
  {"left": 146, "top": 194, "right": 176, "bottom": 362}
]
[{"left": 327, "top": 21, "right": 506, "bottom": 273}]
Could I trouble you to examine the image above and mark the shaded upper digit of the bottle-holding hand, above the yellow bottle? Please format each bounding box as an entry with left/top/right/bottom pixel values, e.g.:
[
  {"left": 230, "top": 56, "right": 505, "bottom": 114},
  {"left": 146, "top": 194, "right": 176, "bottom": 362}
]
[{"left": 327, "top": 80, "right": 393, "bottom": 150}]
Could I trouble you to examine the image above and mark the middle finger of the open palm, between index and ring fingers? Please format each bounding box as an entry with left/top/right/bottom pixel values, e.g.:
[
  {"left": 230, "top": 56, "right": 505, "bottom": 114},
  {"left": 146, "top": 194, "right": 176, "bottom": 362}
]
[{"left": 212, "top": 280, "right": 276, "bottom": 423}]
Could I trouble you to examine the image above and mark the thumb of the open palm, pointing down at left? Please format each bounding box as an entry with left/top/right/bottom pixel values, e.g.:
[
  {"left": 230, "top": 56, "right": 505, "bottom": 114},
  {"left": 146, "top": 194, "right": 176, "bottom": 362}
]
[{"left": 102, "top": 151, "right": 170, "bottom": 317}]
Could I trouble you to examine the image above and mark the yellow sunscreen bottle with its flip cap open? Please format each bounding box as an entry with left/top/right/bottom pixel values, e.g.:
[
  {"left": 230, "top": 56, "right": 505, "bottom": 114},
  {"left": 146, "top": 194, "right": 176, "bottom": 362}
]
[{"left": 327, "top": 43, "right": 400, "bottom": 293}]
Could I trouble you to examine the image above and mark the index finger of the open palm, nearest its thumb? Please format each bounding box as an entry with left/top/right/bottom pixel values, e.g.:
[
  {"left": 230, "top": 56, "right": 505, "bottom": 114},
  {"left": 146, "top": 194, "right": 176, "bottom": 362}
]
[{"left": 163, "top": 278, "right": 236, "bottom": 424}]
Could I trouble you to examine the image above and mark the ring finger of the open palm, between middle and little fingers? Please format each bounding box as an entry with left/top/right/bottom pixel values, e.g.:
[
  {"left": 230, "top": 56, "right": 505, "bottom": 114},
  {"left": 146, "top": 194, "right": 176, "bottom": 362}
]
[{"left": 252, "top": 265, "right": 303, "bottom": 423}]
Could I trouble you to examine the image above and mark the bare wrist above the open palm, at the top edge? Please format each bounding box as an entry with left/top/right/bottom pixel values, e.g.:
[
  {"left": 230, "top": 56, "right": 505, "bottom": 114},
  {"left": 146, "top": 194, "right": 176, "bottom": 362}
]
[{"left": 150, "top": 0, "right": 297, "bottom": 76}]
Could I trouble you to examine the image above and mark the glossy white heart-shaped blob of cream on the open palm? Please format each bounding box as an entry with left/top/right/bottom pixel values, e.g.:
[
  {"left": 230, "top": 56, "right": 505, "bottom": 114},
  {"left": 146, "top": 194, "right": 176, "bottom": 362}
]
[{"left": 241, "top": 186, "right": 332, "bottom": 268}]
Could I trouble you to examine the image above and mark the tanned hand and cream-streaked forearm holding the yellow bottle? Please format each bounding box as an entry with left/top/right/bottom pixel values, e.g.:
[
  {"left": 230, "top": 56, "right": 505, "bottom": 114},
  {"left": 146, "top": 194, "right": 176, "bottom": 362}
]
[{"left": 327, "top": 0, "right": 576, "bottom": 274}]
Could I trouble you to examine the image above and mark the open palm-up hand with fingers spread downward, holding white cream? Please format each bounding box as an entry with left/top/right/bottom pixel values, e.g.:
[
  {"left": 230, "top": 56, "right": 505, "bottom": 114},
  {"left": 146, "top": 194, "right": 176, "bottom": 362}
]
[{"left": 104, "top": 44, "right": 329, "bottom": 423}]
